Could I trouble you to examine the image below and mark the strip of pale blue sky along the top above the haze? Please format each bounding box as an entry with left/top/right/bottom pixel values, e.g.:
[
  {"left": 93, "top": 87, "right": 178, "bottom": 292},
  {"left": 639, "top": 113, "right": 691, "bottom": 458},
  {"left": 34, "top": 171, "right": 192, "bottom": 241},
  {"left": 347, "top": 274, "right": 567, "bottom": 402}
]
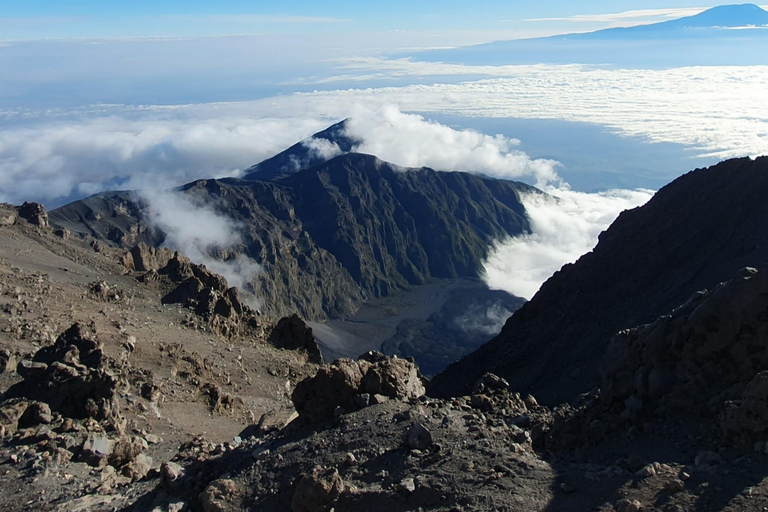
[{"left": 0, "top": 0, "right": 756, "bottom": 44}]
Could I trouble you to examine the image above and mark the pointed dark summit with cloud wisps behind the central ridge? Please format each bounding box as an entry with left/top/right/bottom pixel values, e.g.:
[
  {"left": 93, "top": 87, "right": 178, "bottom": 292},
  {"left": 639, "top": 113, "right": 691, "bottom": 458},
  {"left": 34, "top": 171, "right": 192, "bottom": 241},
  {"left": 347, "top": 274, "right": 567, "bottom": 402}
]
[{"left": 244, "top": 119, "right": 361, "bottom": 181}]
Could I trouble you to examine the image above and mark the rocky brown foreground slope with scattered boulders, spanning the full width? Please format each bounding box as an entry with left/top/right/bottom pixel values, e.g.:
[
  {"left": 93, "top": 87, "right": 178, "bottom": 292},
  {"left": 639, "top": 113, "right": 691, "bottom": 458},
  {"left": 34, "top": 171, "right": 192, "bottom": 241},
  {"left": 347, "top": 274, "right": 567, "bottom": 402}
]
[{"left": 0, "top": 198, "right": 768, "bottom": 512}]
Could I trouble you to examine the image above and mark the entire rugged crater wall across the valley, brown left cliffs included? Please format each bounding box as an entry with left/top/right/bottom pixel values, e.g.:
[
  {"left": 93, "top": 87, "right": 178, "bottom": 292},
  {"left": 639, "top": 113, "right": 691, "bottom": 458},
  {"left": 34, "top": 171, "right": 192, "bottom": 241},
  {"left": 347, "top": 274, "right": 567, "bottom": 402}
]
[{"left": 51, "top": 153, "right": 541, "bottom": 320}]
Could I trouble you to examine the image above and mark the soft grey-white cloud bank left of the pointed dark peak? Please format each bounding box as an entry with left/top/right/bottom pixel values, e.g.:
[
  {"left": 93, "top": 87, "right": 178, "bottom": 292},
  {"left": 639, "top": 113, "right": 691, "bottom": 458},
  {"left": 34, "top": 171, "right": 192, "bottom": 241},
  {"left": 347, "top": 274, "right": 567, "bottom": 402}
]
[{"left": 0, "top": 114, "right": 336, "bottom": 203}]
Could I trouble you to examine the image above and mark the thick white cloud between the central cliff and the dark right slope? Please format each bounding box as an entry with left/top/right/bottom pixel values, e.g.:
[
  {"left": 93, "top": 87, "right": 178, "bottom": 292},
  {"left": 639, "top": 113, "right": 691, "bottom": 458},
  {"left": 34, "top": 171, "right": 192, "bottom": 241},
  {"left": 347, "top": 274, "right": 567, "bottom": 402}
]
[{"left": 484, "top": 188, "right": 653, "bottom": 299}]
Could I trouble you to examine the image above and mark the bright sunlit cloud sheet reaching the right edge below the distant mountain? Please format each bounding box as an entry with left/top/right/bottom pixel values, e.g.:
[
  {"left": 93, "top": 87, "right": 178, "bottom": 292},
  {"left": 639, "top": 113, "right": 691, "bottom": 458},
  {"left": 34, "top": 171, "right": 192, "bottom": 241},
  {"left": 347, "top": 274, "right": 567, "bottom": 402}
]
[{"left": 281, "top": 59, "right": 768, "bottom": 158}]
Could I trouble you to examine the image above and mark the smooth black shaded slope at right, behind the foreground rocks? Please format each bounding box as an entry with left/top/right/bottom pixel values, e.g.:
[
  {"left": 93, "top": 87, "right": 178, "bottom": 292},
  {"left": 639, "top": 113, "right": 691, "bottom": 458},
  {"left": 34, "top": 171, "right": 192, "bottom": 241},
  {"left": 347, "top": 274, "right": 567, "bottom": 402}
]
[{"left": 433, "top": 157, "right": 768, "bottom": 403}]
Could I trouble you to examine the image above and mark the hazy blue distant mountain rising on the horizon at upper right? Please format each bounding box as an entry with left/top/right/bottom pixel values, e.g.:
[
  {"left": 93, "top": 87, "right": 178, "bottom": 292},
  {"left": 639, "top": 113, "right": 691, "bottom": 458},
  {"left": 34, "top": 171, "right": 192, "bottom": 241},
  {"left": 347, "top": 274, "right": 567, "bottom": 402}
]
[{"left": 412, "top": 4, "right": 768, "bottom": 68}]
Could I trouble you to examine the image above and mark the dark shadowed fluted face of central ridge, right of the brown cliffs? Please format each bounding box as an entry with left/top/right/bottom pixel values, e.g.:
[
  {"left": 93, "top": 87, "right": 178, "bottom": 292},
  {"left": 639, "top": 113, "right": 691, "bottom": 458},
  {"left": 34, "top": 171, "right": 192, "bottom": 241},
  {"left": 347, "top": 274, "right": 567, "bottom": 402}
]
[{"left": 277, "top": 153, "right": 535, "bottom": 296}]
